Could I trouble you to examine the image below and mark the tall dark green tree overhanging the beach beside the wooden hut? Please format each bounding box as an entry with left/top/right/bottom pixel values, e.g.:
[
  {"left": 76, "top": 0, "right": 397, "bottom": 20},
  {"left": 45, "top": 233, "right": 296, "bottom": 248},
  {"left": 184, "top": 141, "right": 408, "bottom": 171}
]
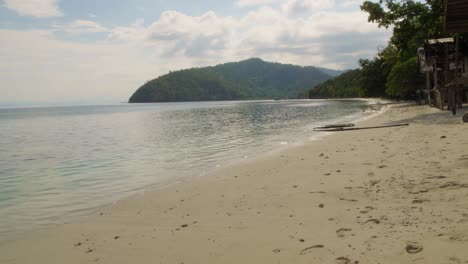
[{"left": 361, "top": 0, "right": 445, "bottom": 97}]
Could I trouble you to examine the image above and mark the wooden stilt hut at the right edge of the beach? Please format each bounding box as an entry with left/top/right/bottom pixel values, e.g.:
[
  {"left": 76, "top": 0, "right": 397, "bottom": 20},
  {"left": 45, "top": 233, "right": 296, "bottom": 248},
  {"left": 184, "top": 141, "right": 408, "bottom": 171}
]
[{"left": 418, "top": 0, "right": 468, "bottom": 114}]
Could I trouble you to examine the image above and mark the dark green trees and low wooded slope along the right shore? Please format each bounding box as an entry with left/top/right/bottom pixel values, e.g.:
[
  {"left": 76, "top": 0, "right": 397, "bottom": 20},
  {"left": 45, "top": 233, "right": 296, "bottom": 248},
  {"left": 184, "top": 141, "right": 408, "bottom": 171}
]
[{"left": 309, "top": 0, "right": 445, "bottom": 98}]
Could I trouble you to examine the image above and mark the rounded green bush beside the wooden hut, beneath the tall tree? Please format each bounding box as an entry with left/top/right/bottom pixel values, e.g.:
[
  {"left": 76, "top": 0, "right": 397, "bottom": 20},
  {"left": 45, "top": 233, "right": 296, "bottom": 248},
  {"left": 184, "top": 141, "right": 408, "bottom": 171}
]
[{"left": 386, "top": 57, "right": 423, "bottom": 98}]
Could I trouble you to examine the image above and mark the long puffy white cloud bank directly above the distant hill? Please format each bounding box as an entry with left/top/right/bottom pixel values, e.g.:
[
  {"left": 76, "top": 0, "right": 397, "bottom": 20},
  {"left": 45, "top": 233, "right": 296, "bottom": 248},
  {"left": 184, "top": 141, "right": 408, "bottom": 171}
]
[{"left": 104, "top": 7, "right": 390, "bottom": 68}]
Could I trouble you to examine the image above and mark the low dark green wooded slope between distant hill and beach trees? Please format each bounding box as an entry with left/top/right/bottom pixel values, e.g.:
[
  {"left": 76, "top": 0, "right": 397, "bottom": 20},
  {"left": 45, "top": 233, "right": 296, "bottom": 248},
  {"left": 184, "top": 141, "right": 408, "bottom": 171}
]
[{"left": 309, "top": 69, "right": 365, "bottom": 98}]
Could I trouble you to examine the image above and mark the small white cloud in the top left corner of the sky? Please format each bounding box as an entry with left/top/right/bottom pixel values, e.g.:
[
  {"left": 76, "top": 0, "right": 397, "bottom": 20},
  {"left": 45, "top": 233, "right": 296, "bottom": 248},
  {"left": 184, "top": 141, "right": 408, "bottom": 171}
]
[{"left": 4, "top": 0, "right": 63, "bottom": 18}]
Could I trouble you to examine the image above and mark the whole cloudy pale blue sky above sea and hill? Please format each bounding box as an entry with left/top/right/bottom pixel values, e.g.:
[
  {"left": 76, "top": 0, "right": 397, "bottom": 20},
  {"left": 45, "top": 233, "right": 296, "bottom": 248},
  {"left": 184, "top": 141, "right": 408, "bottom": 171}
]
[{"left": 0, "top": 0, "right": 391, "bottom": 103}]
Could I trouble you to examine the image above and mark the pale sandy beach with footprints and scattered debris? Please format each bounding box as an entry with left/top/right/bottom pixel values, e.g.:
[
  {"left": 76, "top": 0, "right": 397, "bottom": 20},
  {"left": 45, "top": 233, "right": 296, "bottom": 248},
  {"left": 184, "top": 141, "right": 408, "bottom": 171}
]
[{"left": 0, "top": 103, "right": 468, "bottom": 264}]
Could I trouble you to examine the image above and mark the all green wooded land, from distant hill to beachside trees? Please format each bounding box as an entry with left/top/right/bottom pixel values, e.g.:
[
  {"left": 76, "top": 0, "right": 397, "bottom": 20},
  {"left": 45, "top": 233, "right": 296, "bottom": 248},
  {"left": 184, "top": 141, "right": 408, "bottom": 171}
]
[{"left": 129, "top": 0, "right": 446, "bottom": 103}]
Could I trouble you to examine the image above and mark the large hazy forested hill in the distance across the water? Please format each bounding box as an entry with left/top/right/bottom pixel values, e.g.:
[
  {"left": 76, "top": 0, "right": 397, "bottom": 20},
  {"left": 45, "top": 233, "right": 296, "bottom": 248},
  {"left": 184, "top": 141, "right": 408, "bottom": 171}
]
[{"left": 129, "top": 58, "right": 331, "bottom": 103}]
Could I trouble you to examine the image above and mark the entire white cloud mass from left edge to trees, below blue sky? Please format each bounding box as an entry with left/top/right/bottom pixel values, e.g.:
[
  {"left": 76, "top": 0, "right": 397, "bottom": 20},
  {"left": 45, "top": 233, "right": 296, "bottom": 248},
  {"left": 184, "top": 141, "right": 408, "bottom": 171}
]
[{"left": 0, "top": 7, "right": 391, "bottom": 101}]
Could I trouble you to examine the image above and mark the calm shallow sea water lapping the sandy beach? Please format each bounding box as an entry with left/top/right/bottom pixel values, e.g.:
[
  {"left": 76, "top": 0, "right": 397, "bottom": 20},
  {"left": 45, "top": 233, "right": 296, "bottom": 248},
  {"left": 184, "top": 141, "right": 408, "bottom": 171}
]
[{"left": 0, "top": 100, "right": 369, "bottom": 240}]
